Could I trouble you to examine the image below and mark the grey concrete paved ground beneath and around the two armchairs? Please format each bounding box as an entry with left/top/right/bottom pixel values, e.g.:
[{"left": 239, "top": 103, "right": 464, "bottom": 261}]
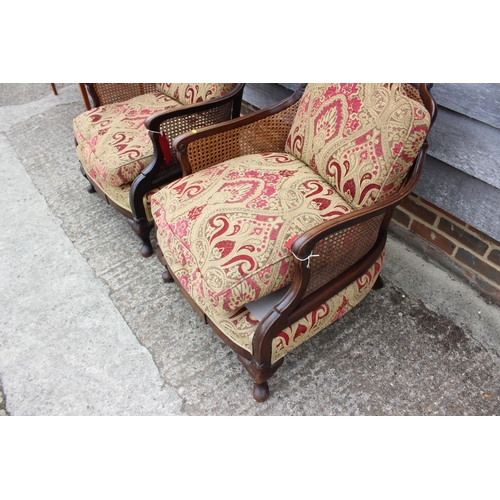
[{"left": 0, "top": 84, "right": 500, "bottom": 416}]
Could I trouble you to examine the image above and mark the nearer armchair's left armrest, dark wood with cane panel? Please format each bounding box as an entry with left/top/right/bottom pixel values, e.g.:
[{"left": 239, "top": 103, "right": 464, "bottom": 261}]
[{"left": 174, "top": 84, "right": 305, "bottom": 175}]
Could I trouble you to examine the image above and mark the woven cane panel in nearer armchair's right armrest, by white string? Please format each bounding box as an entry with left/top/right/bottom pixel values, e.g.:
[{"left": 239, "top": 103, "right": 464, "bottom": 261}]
[{"left": 306, "top": 214, "right": 385, "bottom": 295}]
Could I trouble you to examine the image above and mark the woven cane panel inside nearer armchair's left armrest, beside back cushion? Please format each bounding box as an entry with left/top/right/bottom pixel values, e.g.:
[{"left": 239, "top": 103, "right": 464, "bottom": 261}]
[{"left": 187, "top": 101, "right": 300, "bottom": 173}]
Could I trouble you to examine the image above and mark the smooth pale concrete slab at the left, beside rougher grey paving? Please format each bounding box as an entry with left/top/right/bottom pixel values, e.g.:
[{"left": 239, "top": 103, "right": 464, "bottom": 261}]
[{"left": 0, "top": 92, "right": 181, "bottom": 415}]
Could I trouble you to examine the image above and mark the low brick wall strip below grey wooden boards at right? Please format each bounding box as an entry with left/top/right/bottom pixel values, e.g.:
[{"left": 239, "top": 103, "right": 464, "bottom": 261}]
[{"left": 390, "top": 194, "right": 500, "bottom": 303}]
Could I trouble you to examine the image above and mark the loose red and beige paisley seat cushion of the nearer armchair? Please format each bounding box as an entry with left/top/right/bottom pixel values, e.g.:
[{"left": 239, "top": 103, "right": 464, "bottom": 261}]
[{"left": 151, "top": 153, "right": 352, "bottom": 312}]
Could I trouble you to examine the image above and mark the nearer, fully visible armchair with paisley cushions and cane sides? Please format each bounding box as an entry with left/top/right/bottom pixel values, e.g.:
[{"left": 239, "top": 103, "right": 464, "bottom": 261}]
[{"left": 151, "top": 83, "right": 436, "bottom": 401}]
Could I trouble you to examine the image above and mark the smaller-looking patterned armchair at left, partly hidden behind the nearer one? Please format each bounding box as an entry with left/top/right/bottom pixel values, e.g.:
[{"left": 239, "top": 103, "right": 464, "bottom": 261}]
[{"left": 73, "top": 83, "right": 244, "bottom": 257}]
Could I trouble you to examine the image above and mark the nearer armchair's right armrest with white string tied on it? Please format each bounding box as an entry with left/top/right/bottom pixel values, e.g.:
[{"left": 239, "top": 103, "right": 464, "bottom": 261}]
[{"left": 253, "top": 142, "right": 427, "bottom": 355}]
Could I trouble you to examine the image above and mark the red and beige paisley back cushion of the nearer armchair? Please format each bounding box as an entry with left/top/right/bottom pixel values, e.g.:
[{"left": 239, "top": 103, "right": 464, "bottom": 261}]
[{"left": 286, "top": 83, "right": 431, "bottom": 208}]
